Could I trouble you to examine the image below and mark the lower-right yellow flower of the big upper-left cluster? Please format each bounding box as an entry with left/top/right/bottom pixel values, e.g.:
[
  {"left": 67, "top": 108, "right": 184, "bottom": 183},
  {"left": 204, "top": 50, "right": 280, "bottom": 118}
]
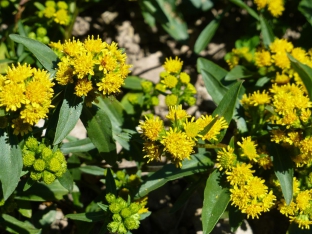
[{"left": 96, "top": 73, "right": 124, "bottom": 95}]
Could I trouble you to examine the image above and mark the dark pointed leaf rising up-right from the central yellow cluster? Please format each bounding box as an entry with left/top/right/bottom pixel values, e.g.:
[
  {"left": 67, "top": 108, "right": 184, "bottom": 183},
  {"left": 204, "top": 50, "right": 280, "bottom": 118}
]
[{"left": 212, "top": 81, "right": 242, "bottom": 123}]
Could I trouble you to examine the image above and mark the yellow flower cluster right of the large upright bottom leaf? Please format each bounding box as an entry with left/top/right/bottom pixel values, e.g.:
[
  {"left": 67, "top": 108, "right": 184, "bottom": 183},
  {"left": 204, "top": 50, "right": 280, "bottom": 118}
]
[{"left": 226, "top": 163, "right": 276, "bottom": 218}]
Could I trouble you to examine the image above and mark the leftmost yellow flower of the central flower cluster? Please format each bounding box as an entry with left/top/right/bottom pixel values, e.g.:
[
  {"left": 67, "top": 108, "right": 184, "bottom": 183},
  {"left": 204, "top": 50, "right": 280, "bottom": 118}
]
[{"left": 140, "top": 117, "right": 164, "bottom": 141}]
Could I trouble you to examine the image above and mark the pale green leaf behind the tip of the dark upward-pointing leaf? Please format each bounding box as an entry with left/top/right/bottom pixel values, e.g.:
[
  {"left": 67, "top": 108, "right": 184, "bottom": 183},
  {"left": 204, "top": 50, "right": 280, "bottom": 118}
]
[{"left": 201, "top": 70, "right": 228, "bottom": 105}]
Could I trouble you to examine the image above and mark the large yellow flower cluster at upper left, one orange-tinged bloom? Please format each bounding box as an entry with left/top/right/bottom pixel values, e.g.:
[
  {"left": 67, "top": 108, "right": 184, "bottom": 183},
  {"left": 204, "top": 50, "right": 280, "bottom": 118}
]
[{"left": 50, "top": 36, "right": 131, "bottom": 105}]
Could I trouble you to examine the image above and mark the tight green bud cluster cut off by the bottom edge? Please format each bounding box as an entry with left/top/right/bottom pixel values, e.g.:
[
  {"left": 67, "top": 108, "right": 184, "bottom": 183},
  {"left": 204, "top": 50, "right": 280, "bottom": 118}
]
[{"left": 105, "top": 193, "right": 141, "bottom": 234}]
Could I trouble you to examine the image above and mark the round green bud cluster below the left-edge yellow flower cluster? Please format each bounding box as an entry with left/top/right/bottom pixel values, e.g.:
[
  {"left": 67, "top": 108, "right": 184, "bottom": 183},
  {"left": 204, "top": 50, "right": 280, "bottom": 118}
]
[{"left": 22, "top": 137, "right": 67, "bottom": 184}]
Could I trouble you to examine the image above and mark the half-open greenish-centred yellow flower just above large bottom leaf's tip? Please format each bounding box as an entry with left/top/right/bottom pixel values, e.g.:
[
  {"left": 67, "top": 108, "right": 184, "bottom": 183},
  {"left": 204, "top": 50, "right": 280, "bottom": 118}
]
[{"left": 216, "top": 145, "right": 237, "bottom": 171}]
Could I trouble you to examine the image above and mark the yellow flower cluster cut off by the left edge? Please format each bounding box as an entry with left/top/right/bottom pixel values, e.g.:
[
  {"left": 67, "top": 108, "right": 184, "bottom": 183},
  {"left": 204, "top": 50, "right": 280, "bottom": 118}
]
[{"left": 0, "top": 64, "right": 54, "bottom": 135}]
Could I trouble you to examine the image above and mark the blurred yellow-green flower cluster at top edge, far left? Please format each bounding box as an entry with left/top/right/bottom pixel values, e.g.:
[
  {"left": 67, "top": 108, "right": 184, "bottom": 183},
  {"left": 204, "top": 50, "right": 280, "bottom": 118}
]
[{"left": 38, "top": 1, "right": 71, "bottom": 25}]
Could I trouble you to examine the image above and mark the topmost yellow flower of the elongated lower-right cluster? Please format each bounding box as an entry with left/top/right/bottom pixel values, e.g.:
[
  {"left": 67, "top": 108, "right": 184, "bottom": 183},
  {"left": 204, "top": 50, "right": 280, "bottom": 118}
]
[{"left": 226, "top": 163, "right": 255, "bottom": 185}]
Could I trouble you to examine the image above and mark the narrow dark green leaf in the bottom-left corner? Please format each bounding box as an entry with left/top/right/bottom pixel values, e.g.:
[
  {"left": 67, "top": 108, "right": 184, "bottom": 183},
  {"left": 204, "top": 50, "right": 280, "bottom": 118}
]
[{"left": 2, "top": 214, "right": 41, "bottom": 234}]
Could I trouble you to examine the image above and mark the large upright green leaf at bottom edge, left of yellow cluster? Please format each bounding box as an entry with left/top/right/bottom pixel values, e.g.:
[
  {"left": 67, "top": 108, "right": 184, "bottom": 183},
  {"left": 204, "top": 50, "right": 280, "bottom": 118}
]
[{"left": 202, "top": 170, "right": 230, "bottom": 234}]
